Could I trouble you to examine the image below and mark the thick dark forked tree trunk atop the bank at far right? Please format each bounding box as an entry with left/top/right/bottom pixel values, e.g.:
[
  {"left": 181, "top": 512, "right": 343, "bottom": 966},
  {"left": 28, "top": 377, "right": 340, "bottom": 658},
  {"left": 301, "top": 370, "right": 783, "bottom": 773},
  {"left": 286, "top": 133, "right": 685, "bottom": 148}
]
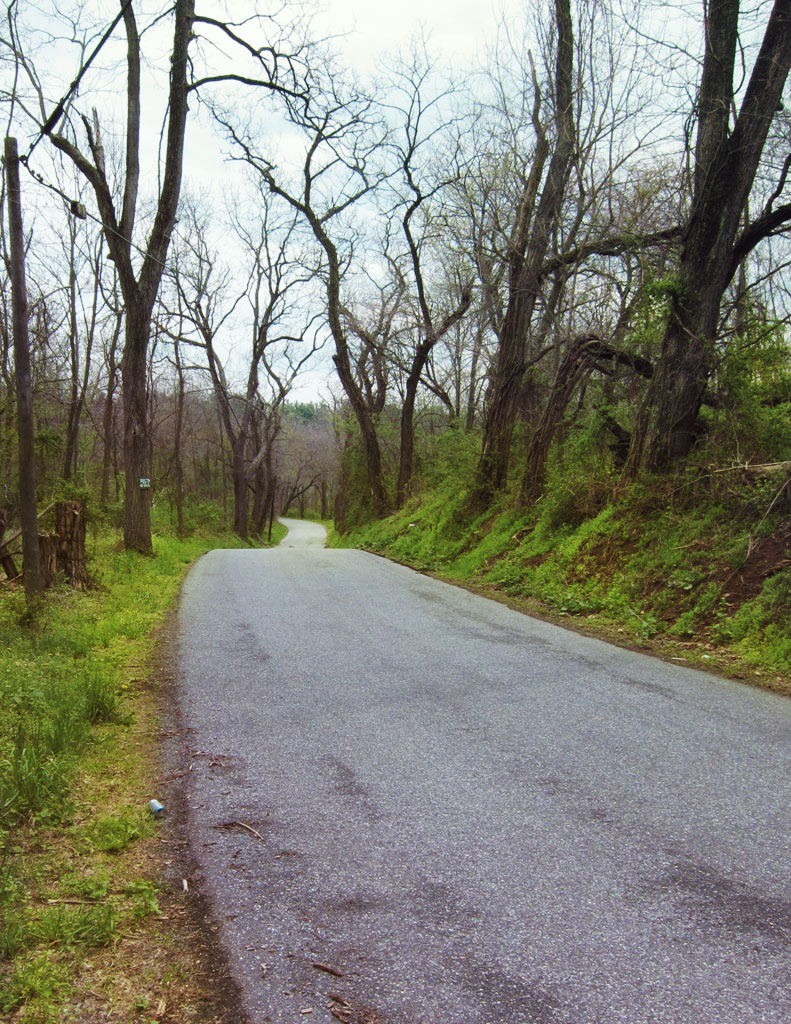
[{"left": 629, "top": 0, "right": 791, "bottom": 471}]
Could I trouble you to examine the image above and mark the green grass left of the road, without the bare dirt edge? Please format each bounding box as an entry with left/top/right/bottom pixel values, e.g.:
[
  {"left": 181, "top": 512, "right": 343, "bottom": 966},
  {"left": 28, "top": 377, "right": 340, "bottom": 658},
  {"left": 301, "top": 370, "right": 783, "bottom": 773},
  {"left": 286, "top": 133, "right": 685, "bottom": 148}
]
[{"left": 0, "top": 517, "right": 285, "bottom": 1024}]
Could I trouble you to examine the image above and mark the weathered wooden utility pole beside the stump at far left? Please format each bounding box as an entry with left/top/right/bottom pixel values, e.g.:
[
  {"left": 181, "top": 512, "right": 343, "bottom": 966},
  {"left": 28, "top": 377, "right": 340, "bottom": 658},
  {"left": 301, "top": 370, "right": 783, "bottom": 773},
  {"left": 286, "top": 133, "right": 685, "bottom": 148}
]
[{"left": 5, "top": 137, "right": 42, "bottom": 601}]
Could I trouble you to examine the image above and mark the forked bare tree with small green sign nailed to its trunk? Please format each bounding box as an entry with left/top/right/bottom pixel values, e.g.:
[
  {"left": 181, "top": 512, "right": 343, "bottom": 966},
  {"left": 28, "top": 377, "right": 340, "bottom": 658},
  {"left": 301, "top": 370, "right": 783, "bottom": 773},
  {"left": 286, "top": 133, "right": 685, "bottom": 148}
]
[{"left": 11, "top": 0, "right": 311, "bottom": 552}]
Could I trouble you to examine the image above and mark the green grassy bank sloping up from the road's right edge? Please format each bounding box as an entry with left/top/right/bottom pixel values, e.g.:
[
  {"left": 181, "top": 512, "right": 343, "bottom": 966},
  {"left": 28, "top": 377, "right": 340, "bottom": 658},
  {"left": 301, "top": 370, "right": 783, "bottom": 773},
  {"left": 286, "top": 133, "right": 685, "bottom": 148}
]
[{"left": 330, "top": 473, "right": 791, "bottom": 695}]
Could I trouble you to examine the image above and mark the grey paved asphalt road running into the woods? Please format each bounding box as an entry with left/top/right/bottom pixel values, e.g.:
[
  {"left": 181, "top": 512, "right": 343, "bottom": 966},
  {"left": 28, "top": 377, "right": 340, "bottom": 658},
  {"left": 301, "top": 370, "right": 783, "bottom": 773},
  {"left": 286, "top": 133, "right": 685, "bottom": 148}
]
[{"left": 179, "top": 525, "right": 791, "bottom": 1024}]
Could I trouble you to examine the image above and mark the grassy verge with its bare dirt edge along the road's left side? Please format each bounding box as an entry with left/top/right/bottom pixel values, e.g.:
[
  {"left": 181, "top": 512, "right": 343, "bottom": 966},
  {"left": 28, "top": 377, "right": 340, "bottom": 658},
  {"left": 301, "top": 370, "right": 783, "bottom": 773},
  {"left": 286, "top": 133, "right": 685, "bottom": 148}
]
[{"left": 0, "top": 527, "right": 285, "bottom": 1024}]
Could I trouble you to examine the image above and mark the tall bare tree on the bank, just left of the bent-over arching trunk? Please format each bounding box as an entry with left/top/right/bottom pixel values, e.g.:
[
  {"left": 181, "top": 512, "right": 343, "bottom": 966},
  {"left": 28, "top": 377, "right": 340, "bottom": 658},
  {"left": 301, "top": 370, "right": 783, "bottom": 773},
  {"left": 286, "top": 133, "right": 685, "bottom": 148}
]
[{"left": 462, "top": 0, "right": 679, "bottom": 501}]
